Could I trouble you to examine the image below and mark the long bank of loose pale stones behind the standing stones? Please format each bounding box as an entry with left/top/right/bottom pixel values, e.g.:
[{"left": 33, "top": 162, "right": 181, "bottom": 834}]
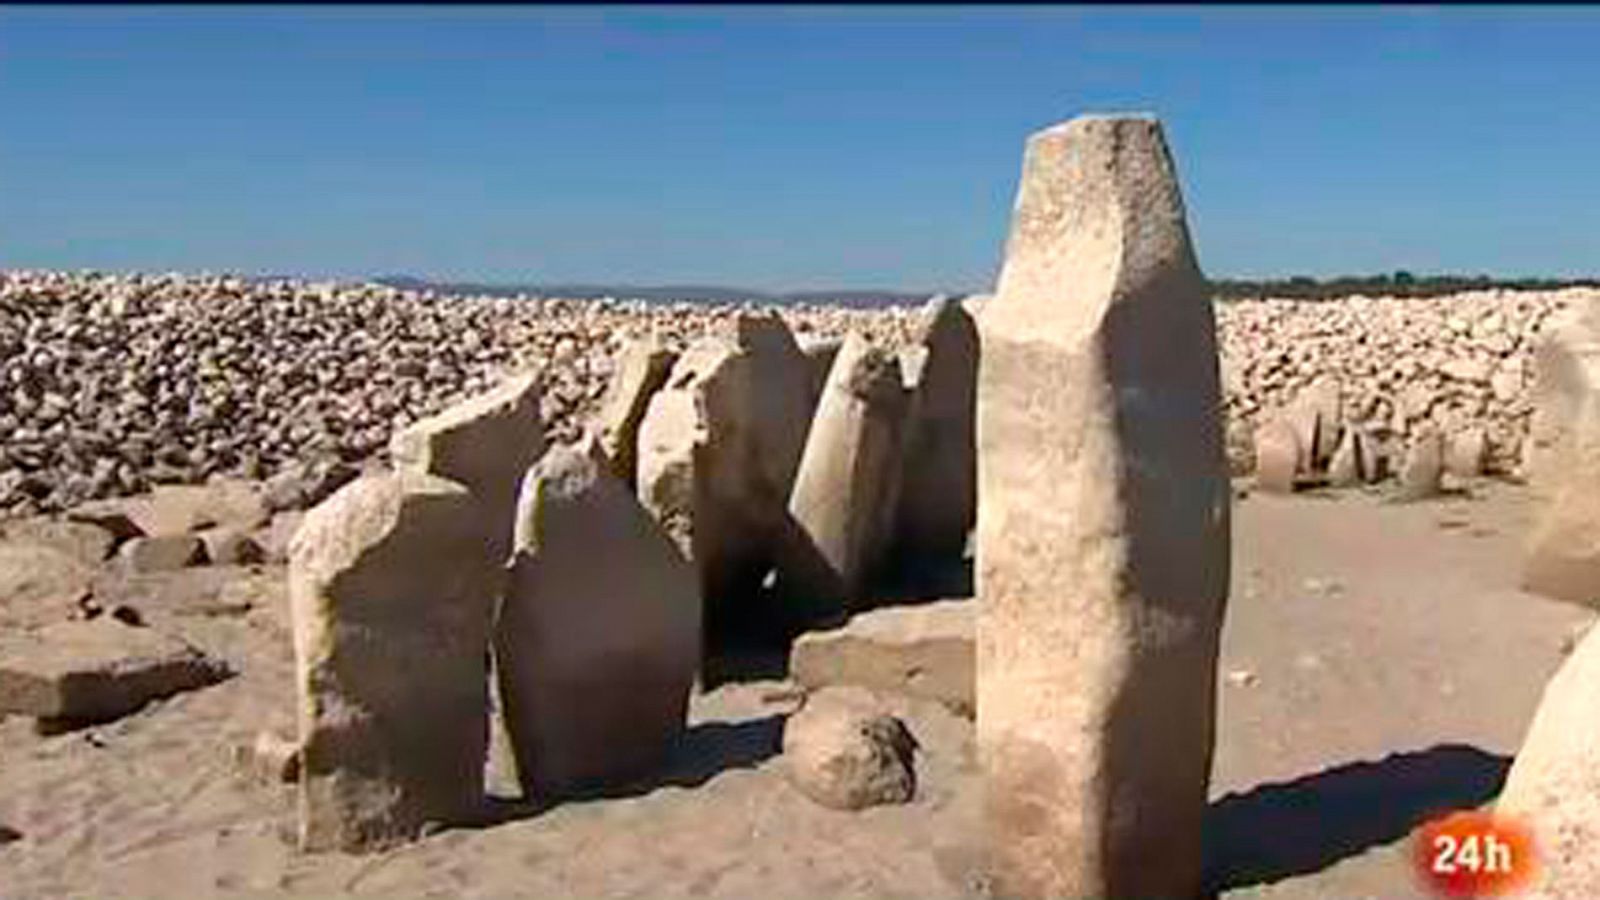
[{"left": 0, "top": 271, "right": 1584, "bottom": 516}]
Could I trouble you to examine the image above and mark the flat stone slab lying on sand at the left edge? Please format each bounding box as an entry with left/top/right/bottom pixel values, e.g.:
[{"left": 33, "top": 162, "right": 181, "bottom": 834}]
[{"left": 0, "top": 617, "right": 230, "bottom": 724}]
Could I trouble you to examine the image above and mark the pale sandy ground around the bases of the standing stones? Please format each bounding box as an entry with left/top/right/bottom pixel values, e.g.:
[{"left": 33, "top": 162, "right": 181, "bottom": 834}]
[{"left": 0, "top": 485, "right": 1590, "bottom": 900}]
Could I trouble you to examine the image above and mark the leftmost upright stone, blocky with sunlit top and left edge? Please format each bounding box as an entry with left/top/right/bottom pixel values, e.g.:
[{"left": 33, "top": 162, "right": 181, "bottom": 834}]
[{"left": 290, "top": 471, "right": 502, "bottom": 850}]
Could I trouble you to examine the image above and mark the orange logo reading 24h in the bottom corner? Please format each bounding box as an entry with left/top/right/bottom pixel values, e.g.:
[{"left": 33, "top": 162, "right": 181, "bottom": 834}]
[{"left": 1411, "top": 812, "right": 1534, "bottom": 897}]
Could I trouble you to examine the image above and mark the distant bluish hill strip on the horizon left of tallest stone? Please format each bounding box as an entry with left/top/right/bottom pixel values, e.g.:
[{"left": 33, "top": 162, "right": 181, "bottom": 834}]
[{"left": 373, "top": 275, "right": 968, "bottom": 309}]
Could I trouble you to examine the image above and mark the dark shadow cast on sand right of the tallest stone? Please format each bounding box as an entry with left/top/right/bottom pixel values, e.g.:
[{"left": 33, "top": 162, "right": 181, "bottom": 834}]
[{"left": 1205, "top": 745, "right": 1510, "bottom": 897}]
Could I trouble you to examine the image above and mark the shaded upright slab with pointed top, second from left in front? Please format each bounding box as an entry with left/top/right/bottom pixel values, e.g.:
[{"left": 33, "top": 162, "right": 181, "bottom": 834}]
[{"left": 494, "top": 439, "right": 701, "bottom": 801}]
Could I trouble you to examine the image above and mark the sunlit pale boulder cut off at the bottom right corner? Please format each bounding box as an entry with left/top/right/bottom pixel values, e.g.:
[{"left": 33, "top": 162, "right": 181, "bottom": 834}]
[{"left": 1494, "top": 621, "right": 1600, "bottom": 900}]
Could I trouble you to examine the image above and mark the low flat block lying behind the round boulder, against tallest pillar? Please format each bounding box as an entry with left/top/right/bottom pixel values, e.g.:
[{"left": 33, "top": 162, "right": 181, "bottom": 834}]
[{"left": 789, "top": 601, "right": 978, "bottom": 717}]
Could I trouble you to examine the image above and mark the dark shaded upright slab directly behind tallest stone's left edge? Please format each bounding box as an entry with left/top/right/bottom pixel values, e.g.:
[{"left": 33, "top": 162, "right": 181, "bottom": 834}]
[{"left": 894, "top": 298, "right": 978, "bottom": 565}]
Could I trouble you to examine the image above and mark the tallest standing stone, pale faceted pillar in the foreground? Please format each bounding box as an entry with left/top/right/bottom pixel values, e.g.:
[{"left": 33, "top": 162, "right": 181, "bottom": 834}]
[{"left": 978, "top": 117, "right": 1230, "bottom": 898}]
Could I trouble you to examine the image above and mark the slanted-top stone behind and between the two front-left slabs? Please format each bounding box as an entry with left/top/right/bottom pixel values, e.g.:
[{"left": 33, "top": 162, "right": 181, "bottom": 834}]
[{"left": 389, "top": 373, "right": 544, "bottom": 559}]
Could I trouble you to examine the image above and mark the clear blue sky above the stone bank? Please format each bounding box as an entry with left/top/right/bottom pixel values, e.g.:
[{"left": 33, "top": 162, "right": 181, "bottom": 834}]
[{"left": 0, "top": 6, "right": 1600, "bottom": 290}]
